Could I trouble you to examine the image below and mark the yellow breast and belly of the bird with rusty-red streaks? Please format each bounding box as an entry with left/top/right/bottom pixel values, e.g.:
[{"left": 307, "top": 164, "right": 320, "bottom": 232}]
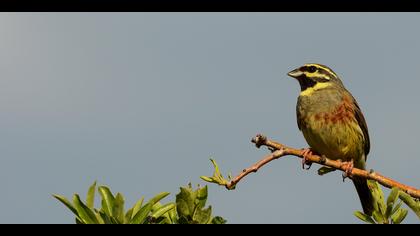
[{"left": 297, "top": 91, "right": 363, "bottom": 161}]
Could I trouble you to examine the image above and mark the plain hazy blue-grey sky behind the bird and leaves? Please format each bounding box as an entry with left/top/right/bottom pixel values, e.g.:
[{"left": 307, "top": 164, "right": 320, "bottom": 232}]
[{"left": 0, "top": 13, "right": 420, "bottom": 223}]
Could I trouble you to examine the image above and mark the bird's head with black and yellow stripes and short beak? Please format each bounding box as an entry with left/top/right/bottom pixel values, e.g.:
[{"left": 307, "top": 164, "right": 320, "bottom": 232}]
[{"left": 287, "top": 63, "right": 343, "bottom": 91}]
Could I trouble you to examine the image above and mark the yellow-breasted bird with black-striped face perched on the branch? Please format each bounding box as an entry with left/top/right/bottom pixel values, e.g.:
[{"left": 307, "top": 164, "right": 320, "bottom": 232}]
[{"left": 288, "top": 64, "right": 373, "bottom": 215}]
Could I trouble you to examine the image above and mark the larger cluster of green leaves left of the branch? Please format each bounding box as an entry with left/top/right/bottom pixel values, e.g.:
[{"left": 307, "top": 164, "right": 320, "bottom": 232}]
[{"left": 53, "top": 182, "right": 226, "bottom": 224}]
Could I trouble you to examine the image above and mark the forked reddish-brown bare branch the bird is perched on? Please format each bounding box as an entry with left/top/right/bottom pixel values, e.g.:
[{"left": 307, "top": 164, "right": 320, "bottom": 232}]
[{"left": 225, "top": 135, "right": 420, "bottom": 199}]
